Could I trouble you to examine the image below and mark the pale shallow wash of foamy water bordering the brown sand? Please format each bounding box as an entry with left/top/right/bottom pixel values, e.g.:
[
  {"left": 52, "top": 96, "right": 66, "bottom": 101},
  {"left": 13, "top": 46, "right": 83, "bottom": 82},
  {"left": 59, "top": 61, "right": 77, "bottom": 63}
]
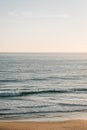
[{"left": 0, "top": 111, "right": 87, "bottom": 122}]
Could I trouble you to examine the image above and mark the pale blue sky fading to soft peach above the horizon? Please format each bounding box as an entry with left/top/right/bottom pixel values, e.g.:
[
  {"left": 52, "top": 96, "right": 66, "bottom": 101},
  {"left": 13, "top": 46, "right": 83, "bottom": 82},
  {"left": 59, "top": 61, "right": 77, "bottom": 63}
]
[{"left": 0, "top": 0, "right": 87, "bottom": 52}]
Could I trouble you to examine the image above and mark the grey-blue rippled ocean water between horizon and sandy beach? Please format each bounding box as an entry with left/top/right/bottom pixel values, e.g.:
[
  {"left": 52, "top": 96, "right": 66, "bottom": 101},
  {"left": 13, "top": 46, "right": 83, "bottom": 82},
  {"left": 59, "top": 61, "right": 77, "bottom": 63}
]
[{"left": 0, "top": 53, "right": 87, "bottom": 121}]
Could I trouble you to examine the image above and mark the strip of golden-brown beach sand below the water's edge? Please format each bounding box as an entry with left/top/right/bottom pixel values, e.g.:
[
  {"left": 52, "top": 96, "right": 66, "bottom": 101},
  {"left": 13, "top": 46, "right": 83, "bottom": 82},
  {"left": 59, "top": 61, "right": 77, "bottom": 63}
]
[{"left": 0, "top": 120, "right": 87, "bottom": 130}]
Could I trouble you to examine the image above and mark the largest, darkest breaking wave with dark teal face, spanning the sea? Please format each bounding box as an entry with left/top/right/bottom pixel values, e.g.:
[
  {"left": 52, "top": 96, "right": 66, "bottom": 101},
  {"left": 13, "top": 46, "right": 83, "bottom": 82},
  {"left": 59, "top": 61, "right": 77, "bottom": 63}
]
[{"left": 0, "top": 88, "right": 87, "bottom": 97}]
